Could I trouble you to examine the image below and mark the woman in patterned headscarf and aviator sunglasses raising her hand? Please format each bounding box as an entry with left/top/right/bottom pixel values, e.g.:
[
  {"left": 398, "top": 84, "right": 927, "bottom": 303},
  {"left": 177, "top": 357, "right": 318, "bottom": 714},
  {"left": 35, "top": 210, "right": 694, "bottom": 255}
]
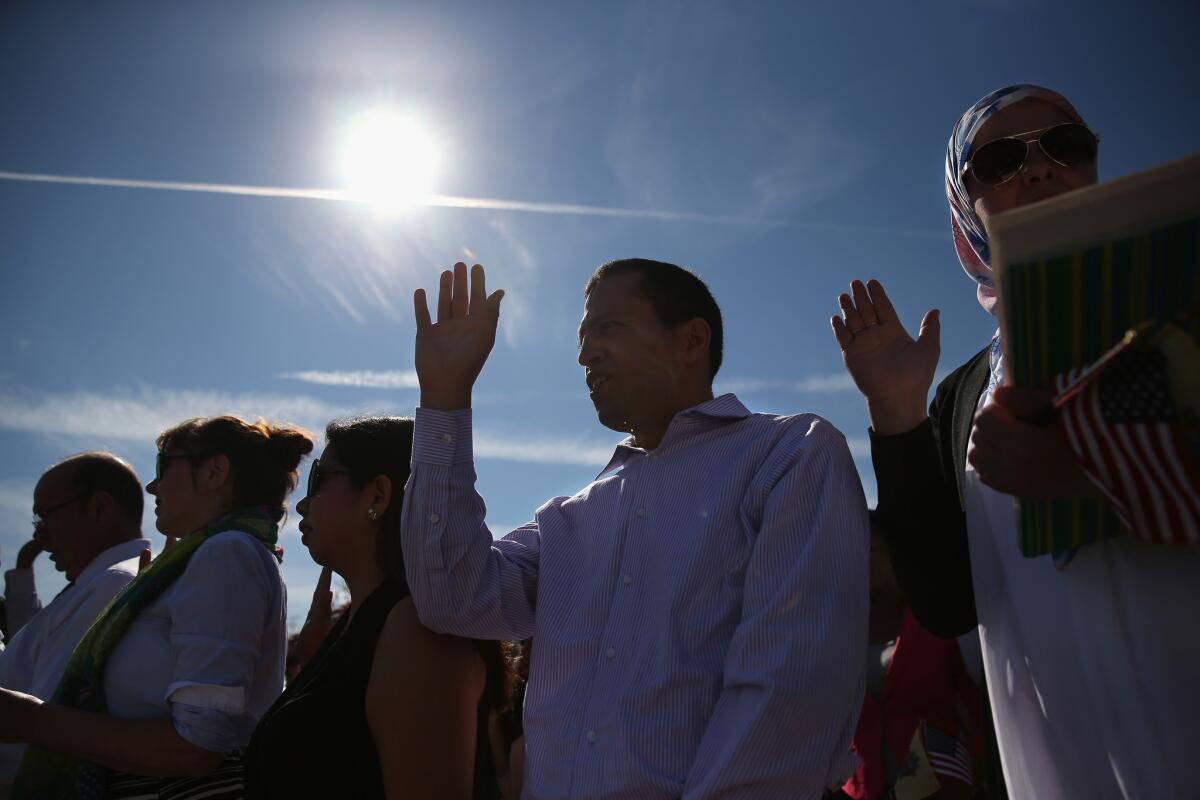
[{"left": 832, "top": 85, "right": 1200, "bottom": 799}]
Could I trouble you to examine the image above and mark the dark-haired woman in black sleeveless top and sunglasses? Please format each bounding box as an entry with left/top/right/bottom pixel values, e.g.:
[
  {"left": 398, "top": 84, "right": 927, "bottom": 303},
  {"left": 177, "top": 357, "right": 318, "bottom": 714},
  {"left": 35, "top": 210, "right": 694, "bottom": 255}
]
[{"left": 246, "top": 417, "right": 508, "bottom": 799}]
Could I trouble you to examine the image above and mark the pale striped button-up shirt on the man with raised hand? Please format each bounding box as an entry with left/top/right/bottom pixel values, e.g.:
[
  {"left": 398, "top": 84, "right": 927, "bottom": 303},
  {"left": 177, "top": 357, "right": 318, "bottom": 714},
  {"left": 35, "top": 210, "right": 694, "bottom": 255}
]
[{"left": 402, "top": 395, "right": 869, "bottom": 800}]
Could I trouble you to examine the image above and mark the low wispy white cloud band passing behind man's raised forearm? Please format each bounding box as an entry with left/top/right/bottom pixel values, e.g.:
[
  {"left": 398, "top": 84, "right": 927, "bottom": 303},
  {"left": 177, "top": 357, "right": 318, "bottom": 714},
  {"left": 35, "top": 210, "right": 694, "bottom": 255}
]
[{"left": 0, "top": 387, "right": 616, "bottom": 470}]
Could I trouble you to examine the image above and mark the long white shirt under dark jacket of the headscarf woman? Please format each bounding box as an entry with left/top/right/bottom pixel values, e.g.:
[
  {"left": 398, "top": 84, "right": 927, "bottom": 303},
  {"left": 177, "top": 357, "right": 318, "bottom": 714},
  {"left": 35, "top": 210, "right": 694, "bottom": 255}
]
[{"left": 966, "top": 340, "right": 1200, "bottom": 800}]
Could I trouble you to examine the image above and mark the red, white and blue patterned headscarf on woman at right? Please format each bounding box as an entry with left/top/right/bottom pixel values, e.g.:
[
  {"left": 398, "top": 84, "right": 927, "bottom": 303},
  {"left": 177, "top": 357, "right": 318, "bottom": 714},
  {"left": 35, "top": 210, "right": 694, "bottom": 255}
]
[{"left": 946, "top": 84, "right": 1084, "bottom": 308}]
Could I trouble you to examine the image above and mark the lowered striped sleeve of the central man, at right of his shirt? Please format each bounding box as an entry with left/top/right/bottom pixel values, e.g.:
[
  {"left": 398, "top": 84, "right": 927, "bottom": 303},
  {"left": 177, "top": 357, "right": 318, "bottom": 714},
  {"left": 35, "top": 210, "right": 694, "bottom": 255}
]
[{"left": 684, "top": 422, "right": 869, "bottom": 799}]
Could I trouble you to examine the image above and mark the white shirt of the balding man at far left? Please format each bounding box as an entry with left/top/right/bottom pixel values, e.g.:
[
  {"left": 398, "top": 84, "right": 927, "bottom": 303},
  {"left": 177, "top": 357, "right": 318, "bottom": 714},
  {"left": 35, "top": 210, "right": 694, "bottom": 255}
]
[{"left": 0, "top": 539, "right": 150, "bottom": 787}]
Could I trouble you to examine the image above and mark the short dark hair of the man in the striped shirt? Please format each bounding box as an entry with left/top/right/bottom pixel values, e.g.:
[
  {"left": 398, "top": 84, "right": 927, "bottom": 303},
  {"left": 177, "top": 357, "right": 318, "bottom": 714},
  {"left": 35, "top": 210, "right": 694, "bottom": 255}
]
[{"left": 583, "top": 258, "right": 725, "bottom": 380}]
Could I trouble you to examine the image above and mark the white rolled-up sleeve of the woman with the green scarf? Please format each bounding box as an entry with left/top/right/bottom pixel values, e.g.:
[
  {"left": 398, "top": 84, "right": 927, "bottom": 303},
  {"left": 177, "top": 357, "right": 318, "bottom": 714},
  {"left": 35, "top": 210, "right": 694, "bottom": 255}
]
[{"left": 164, "top": 531, "right": 282, "bottom": 752}]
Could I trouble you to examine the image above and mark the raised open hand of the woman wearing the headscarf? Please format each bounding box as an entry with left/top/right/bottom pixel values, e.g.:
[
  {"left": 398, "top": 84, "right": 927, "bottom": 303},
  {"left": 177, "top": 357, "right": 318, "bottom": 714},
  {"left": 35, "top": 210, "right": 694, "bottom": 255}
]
[{"left": 829, "top": 281, "right": 941, "bottom": 435}]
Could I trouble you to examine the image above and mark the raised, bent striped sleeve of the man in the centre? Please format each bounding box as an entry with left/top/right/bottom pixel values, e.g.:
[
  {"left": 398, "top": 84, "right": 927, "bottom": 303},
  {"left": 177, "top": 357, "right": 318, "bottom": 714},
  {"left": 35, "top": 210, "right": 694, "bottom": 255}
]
[{"left": 401, "top": 408, "right": 541, "bottom": 639}]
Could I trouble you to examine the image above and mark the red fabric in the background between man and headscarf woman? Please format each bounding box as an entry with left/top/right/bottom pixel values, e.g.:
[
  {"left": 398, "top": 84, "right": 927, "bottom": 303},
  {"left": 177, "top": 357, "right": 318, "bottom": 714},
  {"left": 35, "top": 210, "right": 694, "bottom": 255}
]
[{"left": 841, "top": 610, "right": 980, "bottom": 800}]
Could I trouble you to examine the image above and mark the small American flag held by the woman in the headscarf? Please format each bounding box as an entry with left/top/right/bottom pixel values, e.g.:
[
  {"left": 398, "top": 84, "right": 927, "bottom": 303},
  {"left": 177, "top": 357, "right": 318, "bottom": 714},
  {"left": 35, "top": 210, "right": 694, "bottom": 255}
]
[{"left": 1055, "top": 326, "right": 1200, "bottom": 545}]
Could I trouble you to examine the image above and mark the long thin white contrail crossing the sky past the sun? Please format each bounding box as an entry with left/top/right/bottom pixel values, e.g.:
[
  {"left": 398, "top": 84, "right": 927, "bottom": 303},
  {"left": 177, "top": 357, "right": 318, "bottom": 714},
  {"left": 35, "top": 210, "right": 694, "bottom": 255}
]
[{"left": 0, "top": 172, "right": 946, "bottom": 239}]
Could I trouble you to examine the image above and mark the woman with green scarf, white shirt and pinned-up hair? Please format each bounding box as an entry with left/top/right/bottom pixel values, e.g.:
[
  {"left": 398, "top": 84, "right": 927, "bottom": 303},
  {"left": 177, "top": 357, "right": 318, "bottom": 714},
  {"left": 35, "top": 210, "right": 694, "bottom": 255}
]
[{"left": 0, "top": 416, "right": 312, "bottom": 800}]
